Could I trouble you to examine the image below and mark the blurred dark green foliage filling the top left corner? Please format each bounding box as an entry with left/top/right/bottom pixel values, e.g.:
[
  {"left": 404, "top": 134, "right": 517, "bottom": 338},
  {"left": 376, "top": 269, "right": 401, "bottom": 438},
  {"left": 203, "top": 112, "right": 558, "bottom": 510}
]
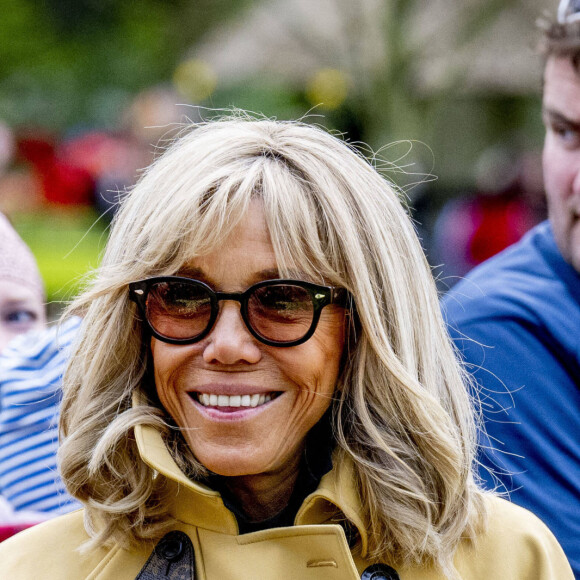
[{"left": 0, "top": 0, "right": 254, "bottom": 130}]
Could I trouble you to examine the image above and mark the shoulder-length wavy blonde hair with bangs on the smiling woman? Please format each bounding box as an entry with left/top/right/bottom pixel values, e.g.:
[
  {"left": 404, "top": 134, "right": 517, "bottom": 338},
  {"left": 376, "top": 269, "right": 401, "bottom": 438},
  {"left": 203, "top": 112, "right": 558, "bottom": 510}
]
[{"left": 61, "top": 116, "right": 484, "bottom": 570}]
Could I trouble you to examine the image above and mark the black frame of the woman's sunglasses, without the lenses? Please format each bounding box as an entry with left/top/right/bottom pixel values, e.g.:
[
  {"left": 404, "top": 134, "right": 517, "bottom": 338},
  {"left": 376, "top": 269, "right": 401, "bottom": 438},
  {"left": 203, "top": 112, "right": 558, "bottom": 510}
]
[{"left": 129, "top": 276, "right": 349, "bottom": 347}]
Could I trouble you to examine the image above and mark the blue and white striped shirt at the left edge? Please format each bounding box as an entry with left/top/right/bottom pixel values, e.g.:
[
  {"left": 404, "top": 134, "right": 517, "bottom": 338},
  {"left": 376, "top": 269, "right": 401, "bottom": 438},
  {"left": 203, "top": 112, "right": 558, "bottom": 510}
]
[{"left": 0, "top": 318, "right": 80, "bottom": 515}]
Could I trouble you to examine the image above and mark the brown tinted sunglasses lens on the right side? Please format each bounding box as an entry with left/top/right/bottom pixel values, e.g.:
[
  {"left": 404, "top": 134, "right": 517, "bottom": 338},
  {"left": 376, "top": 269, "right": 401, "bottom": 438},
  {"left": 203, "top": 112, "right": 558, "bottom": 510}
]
[{"left": 248, "top": 284, "right": 314, "bottom": 342}]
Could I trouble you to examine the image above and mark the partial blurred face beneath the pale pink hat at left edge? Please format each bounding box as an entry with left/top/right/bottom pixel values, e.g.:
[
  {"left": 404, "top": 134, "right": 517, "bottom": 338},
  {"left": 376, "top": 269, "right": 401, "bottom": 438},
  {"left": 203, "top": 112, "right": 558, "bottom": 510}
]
[{"left": 0, "top": 280, "right": 46, "bottom": 352}]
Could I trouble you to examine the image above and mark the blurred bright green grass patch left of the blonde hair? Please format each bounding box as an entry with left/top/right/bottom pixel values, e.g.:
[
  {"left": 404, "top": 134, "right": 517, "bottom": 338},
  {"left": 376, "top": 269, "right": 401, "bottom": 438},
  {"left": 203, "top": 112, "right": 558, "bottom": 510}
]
[{"left": 12, "top": 209, "right": 107, "bottom": 302}]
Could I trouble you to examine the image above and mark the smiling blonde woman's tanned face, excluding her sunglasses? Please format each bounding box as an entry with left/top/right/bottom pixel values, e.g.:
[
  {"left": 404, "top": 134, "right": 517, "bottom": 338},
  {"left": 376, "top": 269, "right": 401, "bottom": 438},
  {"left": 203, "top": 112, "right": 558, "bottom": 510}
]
[{"left": 151, "top": 201, "right": 345, "bottom": 476}]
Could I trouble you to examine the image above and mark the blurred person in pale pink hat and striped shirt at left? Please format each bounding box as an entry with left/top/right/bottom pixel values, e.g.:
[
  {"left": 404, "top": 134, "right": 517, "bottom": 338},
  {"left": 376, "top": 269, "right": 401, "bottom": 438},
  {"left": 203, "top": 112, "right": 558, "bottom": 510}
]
[{"left": 0, "top": 214, "right": 78, "bottom": 538}]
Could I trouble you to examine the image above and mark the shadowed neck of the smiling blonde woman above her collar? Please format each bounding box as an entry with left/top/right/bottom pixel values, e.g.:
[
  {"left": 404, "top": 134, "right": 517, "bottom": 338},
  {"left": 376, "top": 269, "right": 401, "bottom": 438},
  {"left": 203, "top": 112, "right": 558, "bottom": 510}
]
[{"left": 220, "top": 454, "right": 301, "bottom": 522}]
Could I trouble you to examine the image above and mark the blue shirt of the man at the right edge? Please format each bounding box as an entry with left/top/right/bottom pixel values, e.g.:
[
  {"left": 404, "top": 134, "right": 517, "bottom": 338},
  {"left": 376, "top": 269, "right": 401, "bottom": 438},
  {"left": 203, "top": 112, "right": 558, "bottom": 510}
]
[{"left": 442, "top": 222, "right": 580, "bottom": 578}]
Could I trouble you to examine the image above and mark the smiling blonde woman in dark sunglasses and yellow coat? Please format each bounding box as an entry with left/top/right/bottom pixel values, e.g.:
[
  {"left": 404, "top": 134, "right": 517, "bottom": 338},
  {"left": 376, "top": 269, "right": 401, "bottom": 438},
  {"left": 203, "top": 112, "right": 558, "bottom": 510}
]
[{"left": 0, "top": 118, "right": 572, "bottom": 580}]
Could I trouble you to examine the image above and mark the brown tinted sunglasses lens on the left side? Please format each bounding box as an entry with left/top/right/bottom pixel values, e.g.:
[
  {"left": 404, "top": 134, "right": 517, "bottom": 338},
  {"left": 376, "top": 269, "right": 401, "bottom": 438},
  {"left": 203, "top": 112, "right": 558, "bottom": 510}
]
[{"left": 146, "top": 281, "right": 211, "bottom": 339}]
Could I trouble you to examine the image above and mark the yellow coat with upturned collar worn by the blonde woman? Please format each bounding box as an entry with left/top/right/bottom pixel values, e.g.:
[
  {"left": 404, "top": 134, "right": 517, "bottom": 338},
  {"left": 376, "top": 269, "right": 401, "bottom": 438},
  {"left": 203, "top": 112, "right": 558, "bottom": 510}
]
[{"left": 0, "top": 427, "right": 574, "bottom": 580}]
